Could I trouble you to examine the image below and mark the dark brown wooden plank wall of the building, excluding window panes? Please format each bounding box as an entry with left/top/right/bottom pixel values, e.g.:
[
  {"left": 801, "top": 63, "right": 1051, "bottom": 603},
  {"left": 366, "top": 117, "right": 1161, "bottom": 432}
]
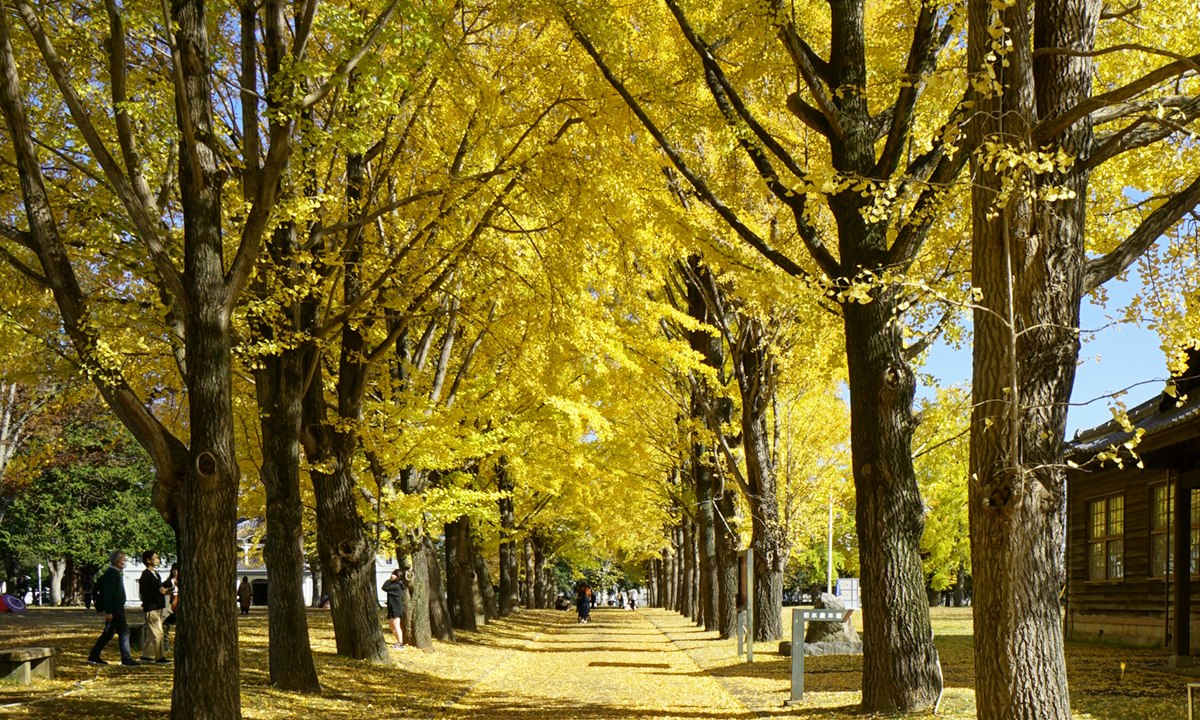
[{"left": 1067, "top": 464, "right": 1200, "bottom": 619}]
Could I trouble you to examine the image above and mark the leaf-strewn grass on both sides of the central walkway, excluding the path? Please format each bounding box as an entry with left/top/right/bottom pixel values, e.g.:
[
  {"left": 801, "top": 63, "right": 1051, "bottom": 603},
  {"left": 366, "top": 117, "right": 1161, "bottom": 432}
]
[{"left": 0, "top": 608, "right": 1194, "bottom": 720}]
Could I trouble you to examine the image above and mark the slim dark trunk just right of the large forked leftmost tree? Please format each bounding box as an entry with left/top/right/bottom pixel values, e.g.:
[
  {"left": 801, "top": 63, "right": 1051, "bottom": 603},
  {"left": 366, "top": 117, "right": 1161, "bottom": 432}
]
[{"left": 254, "top": 331, "right": 320, "bottom": 692}]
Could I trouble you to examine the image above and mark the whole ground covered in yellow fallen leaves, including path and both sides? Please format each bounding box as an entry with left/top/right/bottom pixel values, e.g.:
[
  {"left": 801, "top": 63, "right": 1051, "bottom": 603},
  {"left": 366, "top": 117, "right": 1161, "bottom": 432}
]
[{"left": 0, "top": 608, "right": 1196, "bottom": 720}]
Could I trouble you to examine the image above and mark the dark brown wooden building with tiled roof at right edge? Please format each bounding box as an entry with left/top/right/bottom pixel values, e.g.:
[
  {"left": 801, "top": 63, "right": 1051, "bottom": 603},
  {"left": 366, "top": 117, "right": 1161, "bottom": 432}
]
[{"left": 1064, "top": 348, "right": 1200, "bottom": 666}]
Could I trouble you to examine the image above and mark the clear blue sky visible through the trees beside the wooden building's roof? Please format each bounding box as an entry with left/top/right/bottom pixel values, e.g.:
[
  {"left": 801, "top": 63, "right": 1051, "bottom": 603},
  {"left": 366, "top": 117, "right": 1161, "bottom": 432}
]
[{"left": 917, "top": 270, "right": 1168, "bottom": 438}]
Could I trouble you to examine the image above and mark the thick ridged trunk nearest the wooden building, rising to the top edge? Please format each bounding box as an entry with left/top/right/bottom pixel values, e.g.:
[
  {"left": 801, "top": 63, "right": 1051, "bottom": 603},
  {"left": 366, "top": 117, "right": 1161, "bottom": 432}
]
[{"left": 968, "top": 0, "right": 1100, "bottom": 720}]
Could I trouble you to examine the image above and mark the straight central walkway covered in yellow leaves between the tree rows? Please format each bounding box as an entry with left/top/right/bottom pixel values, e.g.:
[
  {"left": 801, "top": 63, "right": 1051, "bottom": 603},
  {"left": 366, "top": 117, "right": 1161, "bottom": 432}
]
[{"left": 444, "top": 610, "right": 756, "bottom": 720}]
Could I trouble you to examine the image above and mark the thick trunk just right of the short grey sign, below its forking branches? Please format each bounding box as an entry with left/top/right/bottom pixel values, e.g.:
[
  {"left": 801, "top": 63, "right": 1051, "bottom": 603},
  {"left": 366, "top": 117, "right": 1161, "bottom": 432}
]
[{"left": 840, "top": 297, "right": 942, "bottom": 712}]
